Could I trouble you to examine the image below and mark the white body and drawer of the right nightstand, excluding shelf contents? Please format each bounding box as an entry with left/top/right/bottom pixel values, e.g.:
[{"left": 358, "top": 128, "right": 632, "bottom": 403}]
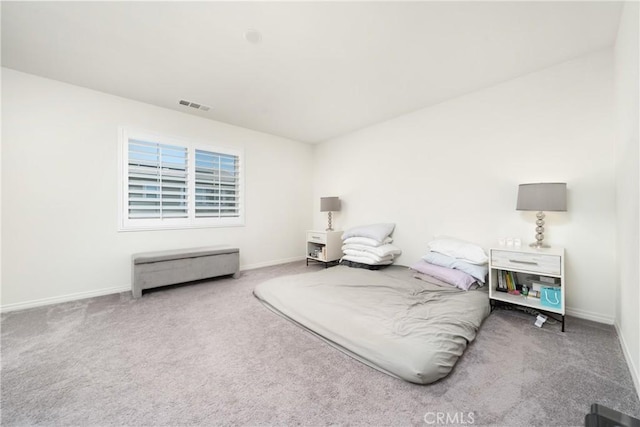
[{"left": 489, "top": 246, "right": 566, "bottom": 332}]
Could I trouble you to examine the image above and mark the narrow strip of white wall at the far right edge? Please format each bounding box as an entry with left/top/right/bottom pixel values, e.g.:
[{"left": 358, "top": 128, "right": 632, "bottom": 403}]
[{"left": 615, "top": 2, "right": 640, "bottom": 391}]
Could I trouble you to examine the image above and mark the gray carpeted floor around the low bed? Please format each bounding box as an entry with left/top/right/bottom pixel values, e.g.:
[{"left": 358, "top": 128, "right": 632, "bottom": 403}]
[{"left": 0, "top": 262, "right": 640, "bottom": 426}]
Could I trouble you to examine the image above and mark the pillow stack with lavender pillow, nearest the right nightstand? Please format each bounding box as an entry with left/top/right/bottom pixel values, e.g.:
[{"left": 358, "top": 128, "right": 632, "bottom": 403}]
[{"left": 411, "top": 237, "right": 489, "bottom": 291}]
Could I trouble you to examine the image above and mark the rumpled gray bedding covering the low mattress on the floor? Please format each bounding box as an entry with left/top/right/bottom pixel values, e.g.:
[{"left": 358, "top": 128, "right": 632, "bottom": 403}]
[{"left": 254, "top": 266, "right": 490, "bottom": 384}]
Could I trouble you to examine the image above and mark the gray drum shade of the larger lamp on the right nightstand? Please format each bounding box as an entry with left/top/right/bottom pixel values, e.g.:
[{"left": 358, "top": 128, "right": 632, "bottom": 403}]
[{"left": 516, "top": 182, "right": 567, "bottom": 212}]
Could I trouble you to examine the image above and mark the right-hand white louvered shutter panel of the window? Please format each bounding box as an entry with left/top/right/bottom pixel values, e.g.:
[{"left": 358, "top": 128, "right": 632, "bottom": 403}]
[{"left": 195, "top": 150, "right": 240, "bottom": 218}]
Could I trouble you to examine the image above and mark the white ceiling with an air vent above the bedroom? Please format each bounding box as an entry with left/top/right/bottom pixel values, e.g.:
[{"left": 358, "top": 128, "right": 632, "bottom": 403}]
[{"left": 1, "top": 1, "right": 621, "bottom": 143}]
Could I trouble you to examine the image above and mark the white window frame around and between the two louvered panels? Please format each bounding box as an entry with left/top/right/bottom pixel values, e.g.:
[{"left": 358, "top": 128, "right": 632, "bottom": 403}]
[{"left": 118, "top": 127, "right": 245, "bottom": 231}]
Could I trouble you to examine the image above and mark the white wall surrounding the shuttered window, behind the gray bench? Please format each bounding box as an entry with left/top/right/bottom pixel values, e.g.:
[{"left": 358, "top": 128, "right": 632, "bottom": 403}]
[{"left": 2, "top": 68, "right": 313, "bottom": 309}]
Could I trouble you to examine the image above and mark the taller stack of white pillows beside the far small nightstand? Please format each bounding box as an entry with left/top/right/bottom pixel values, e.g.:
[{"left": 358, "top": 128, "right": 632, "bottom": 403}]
[{"left": 342, "top": 224, "right": 402, "bottom": 266}]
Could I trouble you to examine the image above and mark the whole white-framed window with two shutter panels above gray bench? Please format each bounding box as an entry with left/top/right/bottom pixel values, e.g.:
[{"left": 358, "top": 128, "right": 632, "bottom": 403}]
[{"left": 120, "top": 129, "right": 244, "bottom": 230}]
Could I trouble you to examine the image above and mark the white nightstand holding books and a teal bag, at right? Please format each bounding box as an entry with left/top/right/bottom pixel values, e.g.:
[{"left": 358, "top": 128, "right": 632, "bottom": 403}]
[{"left": 489, "top": 246, "right": 565, "bottom": 332}]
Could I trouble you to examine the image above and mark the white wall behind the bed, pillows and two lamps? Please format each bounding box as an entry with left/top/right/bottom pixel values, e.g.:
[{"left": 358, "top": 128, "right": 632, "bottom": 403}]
[{"left": 313, "top": 49, "right": 616, "bottom": 327}]
